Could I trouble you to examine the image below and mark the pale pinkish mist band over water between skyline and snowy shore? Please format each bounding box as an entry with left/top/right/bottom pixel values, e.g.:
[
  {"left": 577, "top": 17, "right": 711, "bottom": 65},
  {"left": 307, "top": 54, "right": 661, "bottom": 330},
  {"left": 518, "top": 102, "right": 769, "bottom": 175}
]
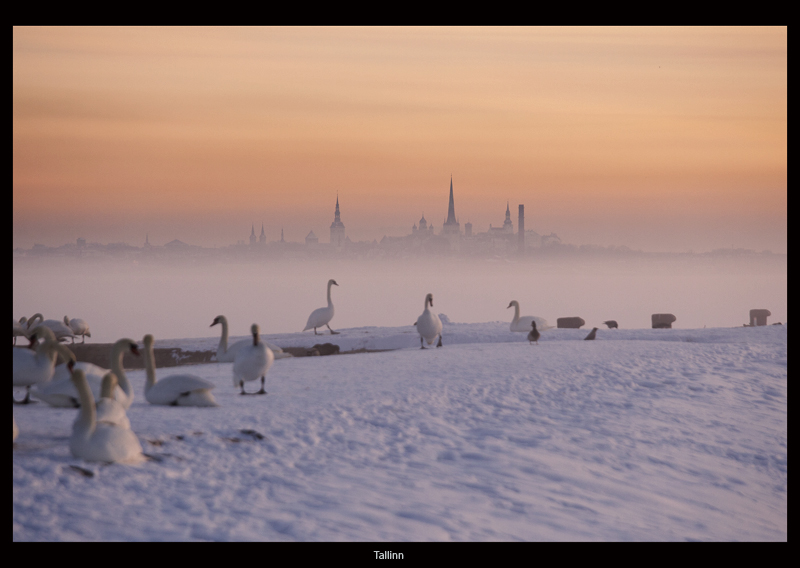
[{"left": 13, "top": 255, "right": 787, "bottom": 345}]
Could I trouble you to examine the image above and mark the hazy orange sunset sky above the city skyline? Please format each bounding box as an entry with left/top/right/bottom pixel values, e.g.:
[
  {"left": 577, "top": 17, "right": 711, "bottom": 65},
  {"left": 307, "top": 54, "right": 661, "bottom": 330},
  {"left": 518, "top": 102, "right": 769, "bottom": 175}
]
[{"left": 13, "top": 27, "right": 787, "bottom": 252}]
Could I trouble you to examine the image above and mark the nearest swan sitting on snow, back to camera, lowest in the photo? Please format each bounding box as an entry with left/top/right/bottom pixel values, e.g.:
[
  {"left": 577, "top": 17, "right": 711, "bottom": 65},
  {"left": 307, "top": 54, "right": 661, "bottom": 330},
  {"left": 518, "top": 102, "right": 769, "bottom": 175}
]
[{"left": 69, "top": 369, "right": 144, "bottom": 463}]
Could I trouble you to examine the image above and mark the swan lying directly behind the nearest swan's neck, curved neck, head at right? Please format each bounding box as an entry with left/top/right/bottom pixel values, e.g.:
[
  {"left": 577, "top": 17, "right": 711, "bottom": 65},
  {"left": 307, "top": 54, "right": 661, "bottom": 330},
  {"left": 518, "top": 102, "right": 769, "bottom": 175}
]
[{"left": 31, "top": 338, "right": 139, "bottom": 409}]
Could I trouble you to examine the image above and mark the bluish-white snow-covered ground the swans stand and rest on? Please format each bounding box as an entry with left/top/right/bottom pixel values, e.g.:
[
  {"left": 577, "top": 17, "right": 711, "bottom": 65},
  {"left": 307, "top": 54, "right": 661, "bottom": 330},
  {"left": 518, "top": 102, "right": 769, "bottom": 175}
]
[{"left": 13, "top": 322, "right": 788, "bottom": 541}]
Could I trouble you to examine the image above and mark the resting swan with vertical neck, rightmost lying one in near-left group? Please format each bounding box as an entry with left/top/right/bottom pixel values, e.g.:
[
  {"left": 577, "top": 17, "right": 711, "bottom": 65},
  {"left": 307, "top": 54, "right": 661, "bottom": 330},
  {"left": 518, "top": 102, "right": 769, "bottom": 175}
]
[{"left": 143, "top": 334, "right": 219, "bottom": 406}]
